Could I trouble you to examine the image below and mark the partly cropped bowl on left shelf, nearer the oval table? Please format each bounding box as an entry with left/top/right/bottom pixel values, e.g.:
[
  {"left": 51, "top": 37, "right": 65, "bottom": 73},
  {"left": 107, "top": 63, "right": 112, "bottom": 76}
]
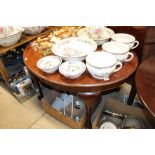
[{"left": 24, "top": 26, "right": 46, "bottom": 35}]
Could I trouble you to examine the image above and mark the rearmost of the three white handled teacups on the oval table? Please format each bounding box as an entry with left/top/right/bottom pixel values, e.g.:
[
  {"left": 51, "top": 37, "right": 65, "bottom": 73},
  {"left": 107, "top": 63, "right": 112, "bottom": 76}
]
[{"left": 112, "top": 33, "right": 139, "bottom": 49}]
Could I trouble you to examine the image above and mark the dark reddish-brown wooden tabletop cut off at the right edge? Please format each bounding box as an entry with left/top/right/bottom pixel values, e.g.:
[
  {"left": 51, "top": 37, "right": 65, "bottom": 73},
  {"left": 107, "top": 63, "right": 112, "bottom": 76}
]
[{"left": 135, "top": 56, "right": 155, "bottom": 117}]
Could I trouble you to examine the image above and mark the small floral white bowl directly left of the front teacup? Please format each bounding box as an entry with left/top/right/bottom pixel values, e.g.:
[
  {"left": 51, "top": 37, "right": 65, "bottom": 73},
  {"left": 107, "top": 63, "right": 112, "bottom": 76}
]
[{"left": 59, "top": 60, "right": 86, "bottom": 79}]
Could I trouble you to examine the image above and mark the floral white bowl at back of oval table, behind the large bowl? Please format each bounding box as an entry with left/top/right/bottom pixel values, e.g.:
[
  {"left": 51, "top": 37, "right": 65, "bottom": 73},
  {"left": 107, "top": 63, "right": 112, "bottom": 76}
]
[{"left": 77, "top": 27, "right": 114, "bottom": 45}]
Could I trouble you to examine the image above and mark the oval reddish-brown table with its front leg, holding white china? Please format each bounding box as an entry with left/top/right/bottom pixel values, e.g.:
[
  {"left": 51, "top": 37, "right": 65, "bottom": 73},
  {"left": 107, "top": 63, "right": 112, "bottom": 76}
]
[{"left": 23, "top": 45, "right": 138, "bottom": 128}]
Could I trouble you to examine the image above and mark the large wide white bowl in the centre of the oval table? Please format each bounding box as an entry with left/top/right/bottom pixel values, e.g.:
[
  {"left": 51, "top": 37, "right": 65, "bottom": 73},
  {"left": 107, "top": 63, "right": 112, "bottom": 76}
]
[{"left": 52, "top": 37, "right": 97, "bottom": 61}]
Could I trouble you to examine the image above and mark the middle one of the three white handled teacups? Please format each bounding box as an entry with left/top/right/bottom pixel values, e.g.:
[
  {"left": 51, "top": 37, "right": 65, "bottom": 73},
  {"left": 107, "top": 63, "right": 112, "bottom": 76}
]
[{"left": 102, "top": 42, "right": 134, "bottom": 62}]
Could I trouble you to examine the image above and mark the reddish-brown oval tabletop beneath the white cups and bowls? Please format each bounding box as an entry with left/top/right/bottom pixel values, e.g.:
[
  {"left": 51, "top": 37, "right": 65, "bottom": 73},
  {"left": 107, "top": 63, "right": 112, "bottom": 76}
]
[{"left": 23, "top": 46, "right": 138, "bottom": 92}]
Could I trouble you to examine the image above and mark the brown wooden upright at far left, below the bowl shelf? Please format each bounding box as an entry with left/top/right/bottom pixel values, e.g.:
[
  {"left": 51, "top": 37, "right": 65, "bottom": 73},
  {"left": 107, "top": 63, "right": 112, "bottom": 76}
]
[{"left": 0, "top": 57, "right": 9, "bottom": 84}]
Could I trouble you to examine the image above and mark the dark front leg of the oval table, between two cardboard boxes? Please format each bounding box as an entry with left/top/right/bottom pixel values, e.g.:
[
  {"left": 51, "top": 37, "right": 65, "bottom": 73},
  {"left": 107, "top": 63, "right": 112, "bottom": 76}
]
[{"left": 78, "top": 92, "right": 101, "bottom": 129}]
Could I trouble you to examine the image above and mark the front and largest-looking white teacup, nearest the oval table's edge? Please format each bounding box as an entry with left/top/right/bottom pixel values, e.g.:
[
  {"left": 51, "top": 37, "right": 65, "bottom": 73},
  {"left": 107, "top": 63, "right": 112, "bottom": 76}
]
[{"left": 86, "top": 52, "right": 122, "bottom": 80}]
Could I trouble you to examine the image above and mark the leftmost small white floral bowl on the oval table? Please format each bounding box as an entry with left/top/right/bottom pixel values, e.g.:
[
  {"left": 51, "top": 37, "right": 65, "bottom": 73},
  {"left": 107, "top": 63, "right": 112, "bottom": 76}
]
[{"left": 37, "top": 56, "right": 62, "bottom": 73}]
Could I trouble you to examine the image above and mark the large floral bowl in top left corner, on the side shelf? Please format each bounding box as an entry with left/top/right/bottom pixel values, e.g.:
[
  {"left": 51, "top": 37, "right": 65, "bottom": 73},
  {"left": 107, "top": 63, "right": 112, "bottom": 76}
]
[{"left": 0, "top": 27, "right": 24, "bottom": 46}]
